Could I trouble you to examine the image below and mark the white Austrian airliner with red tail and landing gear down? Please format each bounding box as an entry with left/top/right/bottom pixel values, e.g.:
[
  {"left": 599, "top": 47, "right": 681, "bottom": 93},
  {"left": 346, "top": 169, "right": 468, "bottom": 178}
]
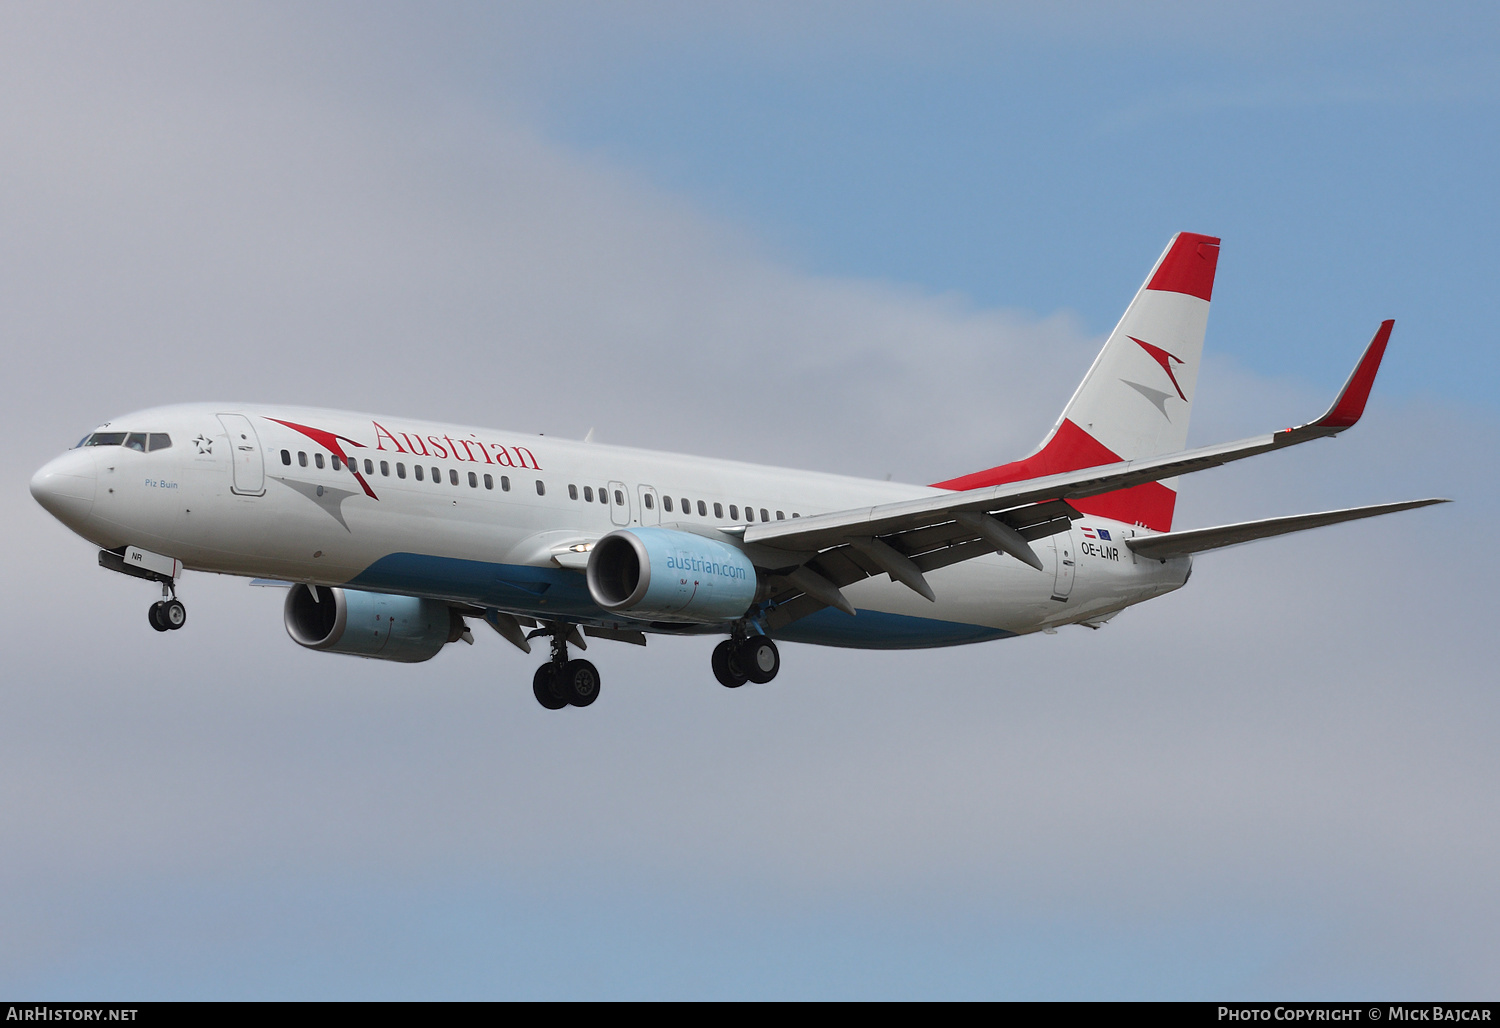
[{"left": 32, "top": 233, "right": 1443, "bottom": 710}]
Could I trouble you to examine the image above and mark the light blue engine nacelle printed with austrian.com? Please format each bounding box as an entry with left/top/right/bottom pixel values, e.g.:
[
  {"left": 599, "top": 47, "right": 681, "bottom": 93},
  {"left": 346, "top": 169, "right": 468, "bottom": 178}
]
[{"left": 588, "top": 528, "right": 756, "bottom": 623}]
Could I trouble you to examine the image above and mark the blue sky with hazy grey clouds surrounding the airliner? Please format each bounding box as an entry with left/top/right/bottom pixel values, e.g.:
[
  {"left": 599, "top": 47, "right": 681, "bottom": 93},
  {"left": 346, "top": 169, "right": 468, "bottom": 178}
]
[{"left": 0, "top": 3, "right": 1500, "bottom": 999}]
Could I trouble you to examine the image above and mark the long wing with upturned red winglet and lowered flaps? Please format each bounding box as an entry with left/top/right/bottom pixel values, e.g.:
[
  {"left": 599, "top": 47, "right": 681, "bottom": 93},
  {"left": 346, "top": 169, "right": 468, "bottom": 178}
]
[{"left": 743, "top": 321, "right": 1394, "bottom": 629}]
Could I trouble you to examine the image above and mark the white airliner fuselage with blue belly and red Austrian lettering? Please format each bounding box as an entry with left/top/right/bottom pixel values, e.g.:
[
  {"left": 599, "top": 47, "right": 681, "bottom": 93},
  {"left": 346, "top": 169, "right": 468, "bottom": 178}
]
[{"left": 32, "top": 404, "right": 1191, "bottom": 648}]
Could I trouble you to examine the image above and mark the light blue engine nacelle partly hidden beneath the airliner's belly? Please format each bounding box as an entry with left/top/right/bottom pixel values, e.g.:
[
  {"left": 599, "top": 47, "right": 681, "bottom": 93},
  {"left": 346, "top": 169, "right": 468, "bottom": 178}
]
[{"left": 284, "top": 585, "right": 464, "bottom": 663}]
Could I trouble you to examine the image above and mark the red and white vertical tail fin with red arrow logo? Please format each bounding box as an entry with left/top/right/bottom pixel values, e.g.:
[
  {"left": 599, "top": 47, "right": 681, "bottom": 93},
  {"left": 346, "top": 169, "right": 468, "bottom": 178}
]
[{"left": 936, "top": 233, "right": 1220, "bottom": 531}]
